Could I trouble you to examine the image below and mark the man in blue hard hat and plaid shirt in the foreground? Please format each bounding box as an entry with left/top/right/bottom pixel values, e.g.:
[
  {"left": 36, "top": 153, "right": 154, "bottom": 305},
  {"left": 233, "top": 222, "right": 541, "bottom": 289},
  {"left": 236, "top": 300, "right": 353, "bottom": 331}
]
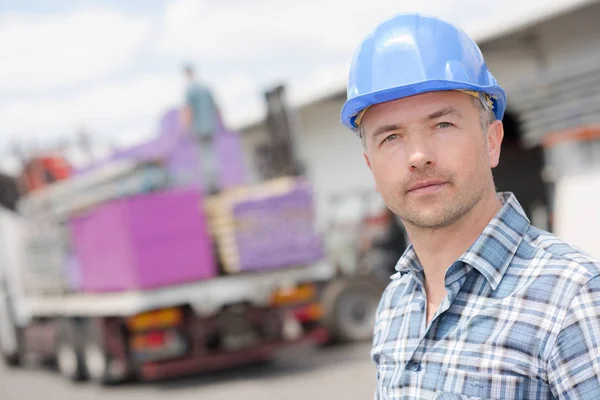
[{"left": 341, "top": 14, "right": 600, "bottom": 400}]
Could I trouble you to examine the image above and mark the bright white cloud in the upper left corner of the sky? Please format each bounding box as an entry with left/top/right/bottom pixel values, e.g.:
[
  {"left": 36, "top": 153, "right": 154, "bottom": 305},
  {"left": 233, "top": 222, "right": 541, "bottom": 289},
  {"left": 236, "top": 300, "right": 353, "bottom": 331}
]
[{"left": 0, "top": 9, "right": 151, "bottom": 93}]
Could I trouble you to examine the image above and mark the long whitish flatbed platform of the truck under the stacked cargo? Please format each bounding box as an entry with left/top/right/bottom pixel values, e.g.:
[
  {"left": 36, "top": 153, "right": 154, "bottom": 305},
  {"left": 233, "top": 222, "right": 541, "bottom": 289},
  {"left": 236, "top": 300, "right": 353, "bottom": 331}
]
[{"left": 25, "top": 261, "right": 334, "bottom": 318}]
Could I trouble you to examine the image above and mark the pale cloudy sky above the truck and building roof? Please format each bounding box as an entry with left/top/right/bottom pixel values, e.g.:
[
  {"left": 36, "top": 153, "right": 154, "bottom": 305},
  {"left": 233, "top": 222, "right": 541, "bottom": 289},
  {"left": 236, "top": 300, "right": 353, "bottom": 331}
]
[{"left": 0, "top": 0, "right": 592, "bottom": 171}]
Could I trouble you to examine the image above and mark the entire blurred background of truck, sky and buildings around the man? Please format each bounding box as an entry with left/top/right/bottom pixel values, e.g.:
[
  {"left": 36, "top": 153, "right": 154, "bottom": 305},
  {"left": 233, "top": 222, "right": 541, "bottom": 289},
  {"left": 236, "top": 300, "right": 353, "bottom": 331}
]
[{"left": 0, "top": 0, "right": 600, "bottom": 400}]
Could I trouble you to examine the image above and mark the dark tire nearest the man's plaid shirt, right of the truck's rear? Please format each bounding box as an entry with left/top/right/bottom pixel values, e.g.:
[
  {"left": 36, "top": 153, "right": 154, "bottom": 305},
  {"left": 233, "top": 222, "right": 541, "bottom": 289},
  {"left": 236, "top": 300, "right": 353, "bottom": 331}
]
[{"left": 323, "top": 279, "right": 381, "bottom": 343}]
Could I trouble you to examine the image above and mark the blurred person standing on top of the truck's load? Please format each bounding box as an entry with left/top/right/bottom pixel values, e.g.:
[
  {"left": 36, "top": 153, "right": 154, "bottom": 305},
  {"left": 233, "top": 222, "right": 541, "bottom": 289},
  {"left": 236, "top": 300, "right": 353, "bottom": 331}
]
[{"left": 184, "top": 65, "right": 223, "bottom": 194}]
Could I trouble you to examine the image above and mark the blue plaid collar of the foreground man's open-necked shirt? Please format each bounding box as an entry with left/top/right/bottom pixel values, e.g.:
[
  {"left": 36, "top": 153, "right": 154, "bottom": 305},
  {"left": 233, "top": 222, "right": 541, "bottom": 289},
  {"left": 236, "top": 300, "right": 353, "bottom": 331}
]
[{"left": 395, "top": 192, "right": 530, "bottom": 290}]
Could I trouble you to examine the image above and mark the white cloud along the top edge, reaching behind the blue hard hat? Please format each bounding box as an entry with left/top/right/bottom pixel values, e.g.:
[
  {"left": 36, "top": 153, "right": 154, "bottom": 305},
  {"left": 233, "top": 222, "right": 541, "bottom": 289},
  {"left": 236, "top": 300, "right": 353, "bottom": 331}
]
[{"left": 158, "top": 0, "right": 500, "bottom": 62}]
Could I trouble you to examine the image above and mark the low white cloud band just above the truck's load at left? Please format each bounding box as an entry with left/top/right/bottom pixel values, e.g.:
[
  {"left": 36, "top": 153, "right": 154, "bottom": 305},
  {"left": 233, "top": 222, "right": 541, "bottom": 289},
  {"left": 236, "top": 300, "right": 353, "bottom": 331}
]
[{"left": 0, "top": 74, "right": 181, "bottom": 145}]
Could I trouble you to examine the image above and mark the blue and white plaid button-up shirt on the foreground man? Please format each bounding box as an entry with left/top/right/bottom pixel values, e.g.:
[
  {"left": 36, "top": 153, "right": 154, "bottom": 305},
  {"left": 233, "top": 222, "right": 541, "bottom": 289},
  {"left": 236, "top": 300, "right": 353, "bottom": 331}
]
[{"left": 371, "top": 193, "right": 600, "bottom": 400}]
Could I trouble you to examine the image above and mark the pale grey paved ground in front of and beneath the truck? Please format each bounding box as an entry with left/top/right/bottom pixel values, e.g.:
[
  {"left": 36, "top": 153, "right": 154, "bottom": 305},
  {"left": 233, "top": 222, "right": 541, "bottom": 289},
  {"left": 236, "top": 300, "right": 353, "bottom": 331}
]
[{"left": 0, "top": 344, "right": 375, "bottom": 400}]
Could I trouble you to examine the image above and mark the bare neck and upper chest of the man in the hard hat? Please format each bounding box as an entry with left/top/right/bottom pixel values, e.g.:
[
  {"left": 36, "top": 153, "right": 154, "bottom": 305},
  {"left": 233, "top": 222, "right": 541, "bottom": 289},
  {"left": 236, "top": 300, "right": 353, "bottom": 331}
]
[{"left": 406, "top": 191, "right": 502, "bottom": 297}]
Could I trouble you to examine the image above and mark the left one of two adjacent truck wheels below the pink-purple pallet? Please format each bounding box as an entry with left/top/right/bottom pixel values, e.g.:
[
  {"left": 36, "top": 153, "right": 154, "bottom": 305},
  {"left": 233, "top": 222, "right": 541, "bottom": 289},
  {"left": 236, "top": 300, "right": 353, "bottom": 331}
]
[{"left": 56, "top": 320, "right": 86, "bottom": 382}]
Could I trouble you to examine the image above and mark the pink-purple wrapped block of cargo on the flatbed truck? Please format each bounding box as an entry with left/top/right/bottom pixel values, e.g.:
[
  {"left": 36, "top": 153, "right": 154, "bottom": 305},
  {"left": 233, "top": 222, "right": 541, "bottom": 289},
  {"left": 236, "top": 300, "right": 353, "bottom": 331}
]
[{"left": 70, "top": 189, "right": 217, "bottom": 292}]
